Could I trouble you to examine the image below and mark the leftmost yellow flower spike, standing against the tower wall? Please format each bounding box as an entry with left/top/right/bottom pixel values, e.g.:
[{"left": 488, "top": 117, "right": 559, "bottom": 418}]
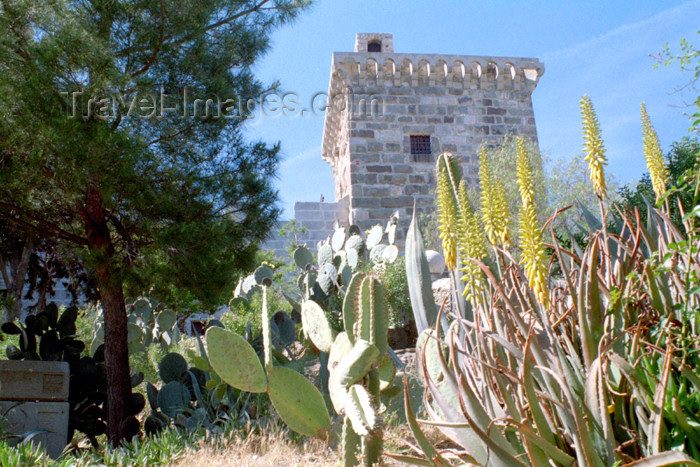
[{"left": 436, "top": 153, "right": 462, "bottom": 271}]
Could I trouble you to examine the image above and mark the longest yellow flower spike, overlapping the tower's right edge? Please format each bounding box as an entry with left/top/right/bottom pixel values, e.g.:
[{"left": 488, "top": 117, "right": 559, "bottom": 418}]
[{"left": 518, "top": 145, "right": 549, "bottom": 303}]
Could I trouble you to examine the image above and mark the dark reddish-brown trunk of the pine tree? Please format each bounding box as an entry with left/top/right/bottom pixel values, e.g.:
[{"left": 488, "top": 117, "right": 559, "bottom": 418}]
[{"left": 83, "top": 188, "right": 131, "bottom": 446}]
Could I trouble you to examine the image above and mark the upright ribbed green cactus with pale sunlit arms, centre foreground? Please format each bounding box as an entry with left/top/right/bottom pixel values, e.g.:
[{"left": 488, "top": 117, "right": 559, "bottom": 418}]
[{"left": 303, "top": 272, "right": 396, "bottom": 466}]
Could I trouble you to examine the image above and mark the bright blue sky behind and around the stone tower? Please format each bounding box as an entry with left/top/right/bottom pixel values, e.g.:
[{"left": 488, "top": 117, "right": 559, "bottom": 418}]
[{"left": 246, "top": 0, "right": 700, "bottom": 219}]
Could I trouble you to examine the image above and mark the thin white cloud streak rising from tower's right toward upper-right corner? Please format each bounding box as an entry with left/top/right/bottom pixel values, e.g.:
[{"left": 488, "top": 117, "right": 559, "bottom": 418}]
[{"left": 542, "top": 0, "right": 700, "bottom": 62}]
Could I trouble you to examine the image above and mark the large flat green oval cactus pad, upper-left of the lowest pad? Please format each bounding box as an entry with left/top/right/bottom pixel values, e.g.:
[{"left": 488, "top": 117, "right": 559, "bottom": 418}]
[{"left": 206, "top": 327, "right": 267, "bottom": 393}]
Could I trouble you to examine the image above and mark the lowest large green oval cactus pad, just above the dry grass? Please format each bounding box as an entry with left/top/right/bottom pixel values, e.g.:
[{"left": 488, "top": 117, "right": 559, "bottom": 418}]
[{"left": 268, "top": 367, "right": 331, "bottom": 439}]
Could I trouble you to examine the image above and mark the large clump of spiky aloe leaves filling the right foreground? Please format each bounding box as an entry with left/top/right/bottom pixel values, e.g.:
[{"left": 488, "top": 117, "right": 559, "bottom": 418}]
[{"left": 394, "top": 122, "right": 700, "bottom": 466}]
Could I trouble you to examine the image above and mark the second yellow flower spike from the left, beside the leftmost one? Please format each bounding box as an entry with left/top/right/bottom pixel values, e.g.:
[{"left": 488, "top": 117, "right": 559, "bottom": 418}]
[{"left": 457, "top": 180, "right": 486, "bottom": 306}]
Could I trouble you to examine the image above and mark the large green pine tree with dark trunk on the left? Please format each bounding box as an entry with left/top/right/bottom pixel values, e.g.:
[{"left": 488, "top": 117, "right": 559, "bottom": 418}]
[{"left": 0, "top": 0, "right": 308, "bottom": 444}]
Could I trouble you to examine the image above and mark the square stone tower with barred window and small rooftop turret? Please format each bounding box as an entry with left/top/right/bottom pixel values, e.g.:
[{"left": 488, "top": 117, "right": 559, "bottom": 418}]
[{"left": 320, "top": 33, "right": 544, "bottom": 241}]
